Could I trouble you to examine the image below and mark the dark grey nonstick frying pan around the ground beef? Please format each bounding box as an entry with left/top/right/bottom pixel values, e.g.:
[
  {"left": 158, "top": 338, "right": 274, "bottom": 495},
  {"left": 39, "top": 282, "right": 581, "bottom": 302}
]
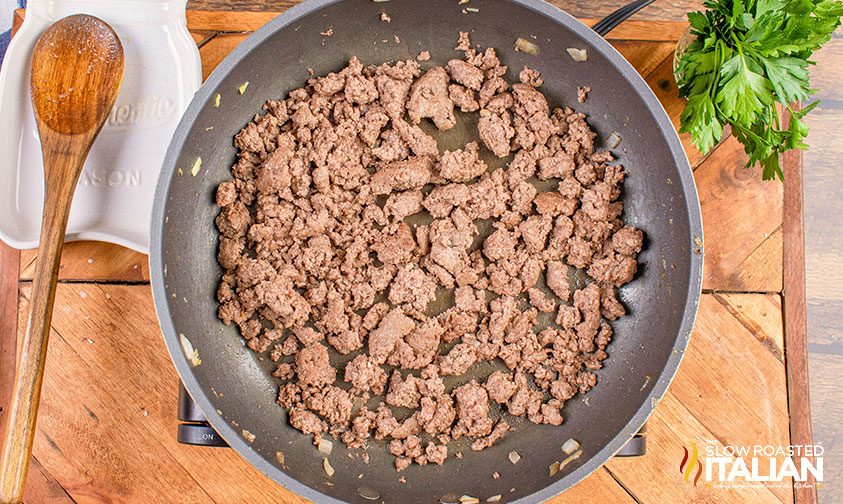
[{"left": 150, "top": 0, "right": 702, "bottom": 503}]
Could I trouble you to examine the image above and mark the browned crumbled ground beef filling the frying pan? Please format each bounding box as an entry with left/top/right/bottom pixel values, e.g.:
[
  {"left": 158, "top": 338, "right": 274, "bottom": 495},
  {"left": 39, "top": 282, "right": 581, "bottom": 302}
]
[{"left": 216, "top": 31, "right": 644, "bottom": 471}]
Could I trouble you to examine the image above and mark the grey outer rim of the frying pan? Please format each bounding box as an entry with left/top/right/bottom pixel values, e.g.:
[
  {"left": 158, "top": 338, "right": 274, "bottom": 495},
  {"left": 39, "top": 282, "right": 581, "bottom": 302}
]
[{"left": 149, "top": 0, "right": 703, "bottom": 504}]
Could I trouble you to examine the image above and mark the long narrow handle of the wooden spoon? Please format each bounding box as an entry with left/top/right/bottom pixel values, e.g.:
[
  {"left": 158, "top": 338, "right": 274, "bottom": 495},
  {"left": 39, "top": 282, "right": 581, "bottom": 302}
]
[{"left": 0, "top": 156, "right": 84, "bottom": 504}]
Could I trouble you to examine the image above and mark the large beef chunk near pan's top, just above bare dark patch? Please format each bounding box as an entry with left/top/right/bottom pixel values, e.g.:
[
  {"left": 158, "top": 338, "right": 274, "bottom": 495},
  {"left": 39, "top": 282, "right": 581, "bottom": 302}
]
[{"left": 407, "top": 67, "right": 456, "bottom": 130}]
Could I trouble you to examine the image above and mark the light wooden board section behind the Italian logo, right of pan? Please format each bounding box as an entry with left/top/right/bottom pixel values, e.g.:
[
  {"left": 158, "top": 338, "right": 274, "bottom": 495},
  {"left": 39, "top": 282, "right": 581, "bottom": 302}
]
[{"left": 607, "top": 294, "right": 793, "bottom": 503}]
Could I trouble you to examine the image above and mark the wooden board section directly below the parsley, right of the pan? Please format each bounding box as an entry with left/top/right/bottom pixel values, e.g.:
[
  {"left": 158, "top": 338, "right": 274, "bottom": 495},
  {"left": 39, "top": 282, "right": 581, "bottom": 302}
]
[{"left": 694, "top": 137, "right": 782, "bottom": 292}]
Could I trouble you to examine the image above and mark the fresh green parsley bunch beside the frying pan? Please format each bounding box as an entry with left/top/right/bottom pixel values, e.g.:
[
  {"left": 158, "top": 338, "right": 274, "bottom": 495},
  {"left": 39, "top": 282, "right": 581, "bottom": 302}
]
[{"left": 676, "top": 0, "right": 843, "bottom": 180}]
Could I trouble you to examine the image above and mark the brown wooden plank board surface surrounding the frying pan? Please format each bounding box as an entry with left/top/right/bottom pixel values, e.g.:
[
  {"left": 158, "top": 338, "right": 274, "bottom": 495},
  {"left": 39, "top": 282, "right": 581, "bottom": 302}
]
[{"left": 0, "top": 0, "right": 832, "bottom": 503}]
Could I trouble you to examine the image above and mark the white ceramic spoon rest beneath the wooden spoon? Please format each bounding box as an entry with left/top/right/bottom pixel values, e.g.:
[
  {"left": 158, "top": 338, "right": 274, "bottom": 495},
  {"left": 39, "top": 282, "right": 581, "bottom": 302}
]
[{"left": 0, "top": 0, "right": 202, "bottom": 253}]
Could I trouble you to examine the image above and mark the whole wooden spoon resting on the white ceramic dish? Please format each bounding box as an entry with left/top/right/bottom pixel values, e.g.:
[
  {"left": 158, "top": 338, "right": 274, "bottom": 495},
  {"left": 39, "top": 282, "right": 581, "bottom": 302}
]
[{"left": 0, "top": 14, "right": 123, "bottom": 504}]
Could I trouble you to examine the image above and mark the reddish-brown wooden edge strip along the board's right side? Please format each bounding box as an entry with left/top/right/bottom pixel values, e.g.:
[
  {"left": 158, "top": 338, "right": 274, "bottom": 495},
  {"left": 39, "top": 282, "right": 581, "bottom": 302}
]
[{"left": 782, "top": 107, "right": 817, "bottom": 504}]
